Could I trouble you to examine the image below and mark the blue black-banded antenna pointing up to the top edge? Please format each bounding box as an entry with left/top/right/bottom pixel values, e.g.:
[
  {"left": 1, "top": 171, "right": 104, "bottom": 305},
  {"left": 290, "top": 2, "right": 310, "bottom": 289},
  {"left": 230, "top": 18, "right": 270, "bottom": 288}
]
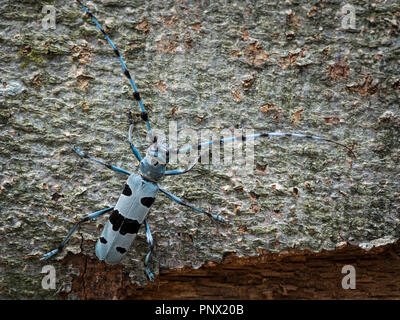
[{"left": 75, "top": 0, "right": 151, "bottom": 133}]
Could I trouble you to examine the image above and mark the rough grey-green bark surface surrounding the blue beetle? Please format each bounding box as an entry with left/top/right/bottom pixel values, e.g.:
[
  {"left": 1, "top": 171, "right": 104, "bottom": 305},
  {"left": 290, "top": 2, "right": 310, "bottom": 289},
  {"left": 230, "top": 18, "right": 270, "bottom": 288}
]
[{"left": 0, "top": 0, "right": 400, "bottom": 299}]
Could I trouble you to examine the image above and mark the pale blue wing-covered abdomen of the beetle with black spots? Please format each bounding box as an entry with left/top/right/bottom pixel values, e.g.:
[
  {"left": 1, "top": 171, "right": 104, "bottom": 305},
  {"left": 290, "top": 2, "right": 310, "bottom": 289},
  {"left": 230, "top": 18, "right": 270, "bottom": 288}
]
[{"left": 96, "top": 174, "right": 158, "bottom": 264}]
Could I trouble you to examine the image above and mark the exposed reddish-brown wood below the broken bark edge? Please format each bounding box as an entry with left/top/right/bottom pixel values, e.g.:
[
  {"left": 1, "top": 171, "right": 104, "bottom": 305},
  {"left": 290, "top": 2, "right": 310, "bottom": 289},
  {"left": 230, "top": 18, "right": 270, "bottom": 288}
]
[{"left": 63, "top": 242, "right": 400, "bottom": 299}]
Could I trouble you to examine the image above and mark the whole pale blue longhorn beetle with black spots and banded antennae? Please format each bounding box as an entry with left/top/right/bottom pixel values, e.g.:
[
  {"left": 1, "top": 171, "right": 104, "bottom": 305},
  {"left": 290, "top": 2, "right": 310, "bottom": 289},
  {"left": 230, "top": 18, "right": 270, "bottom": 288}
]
[{"left": 41, "top": 0, "right": 355, "bottom": 281}]
